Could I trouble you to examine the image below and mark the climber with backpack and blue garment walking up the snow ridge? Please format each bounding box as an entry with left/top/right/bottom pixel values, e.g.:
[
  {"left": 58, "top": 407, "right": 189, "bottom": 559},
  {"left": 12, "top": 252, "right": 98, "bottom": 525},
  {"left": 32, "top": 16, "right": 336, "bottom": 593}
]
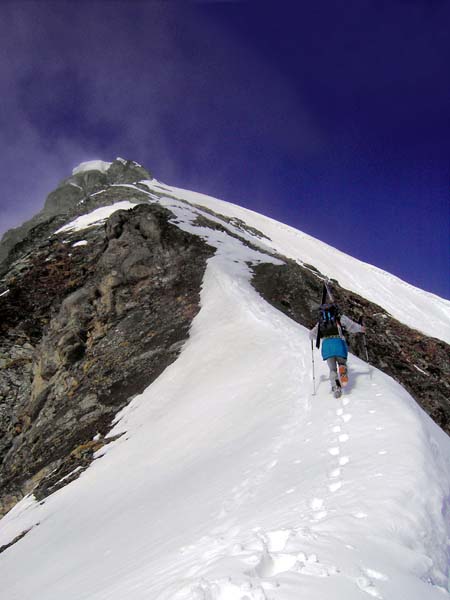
[{"left": 309, "top": 302, "right": 365, "bottom": 398}]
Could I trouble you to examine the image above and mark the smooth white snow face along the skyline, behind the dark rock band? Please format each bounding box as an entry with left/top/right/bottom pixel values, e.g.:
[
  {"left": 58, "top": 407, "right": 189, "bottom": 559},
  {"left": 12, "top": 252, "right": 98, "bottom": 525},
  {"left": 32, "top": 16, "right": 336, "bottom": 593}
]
[{"left": 147, "top": 180, "right": 450, "bottom": 343}]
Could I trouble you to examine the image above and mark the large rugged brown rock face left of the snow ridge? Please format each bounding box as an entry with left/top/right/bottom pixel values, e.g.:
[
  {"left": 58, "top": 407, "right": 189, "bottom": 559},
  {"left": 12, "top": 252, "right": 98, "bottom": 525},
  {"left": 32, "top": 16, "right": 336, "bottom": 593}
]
[{"left": 0, "top": 204, "right": 213, "bottom": 514}]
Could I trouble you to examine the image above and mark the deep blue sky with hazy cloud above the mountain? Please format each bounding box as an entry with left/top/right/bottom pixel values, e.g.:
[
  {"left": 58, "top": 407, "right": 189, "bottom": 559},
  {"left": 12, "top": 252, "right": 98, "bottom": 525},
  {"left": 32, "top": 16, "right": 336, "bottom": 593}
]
[{"left": 0, "top": 0, "right": 450, "bottom": 298}]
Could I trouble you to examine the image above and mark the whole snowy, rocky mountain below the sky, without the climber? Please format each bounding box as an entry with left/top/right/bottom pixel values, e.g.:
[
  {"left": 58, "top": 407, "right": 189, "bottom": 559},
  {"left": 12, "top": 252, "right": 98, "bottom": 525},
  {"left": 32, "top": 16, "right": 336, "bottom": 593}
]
[{"left": 0, "top": 159, "right": 450, "bottom": 600}]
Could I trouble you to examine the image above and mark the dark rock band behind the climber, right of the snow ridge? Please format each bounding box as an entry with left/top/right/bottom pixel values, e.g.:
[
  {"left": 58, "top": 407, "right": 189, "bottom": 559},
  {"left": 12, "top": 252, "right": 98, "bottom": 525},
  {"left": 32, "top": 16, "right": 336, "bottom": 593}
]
[{"left": 253, "top": 260, "right": 450, "bottom": 434}]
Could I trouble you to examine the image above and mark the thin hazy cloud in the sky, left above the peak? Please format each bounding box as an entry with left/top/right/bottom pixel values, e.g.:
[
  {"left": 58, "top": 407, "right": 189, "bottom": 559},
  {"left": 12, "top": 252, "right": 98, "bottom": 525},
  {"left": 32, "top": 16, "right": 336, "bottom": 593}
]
[{"left": 0, "top": 2, "right": 323, "bottom": 230}]
